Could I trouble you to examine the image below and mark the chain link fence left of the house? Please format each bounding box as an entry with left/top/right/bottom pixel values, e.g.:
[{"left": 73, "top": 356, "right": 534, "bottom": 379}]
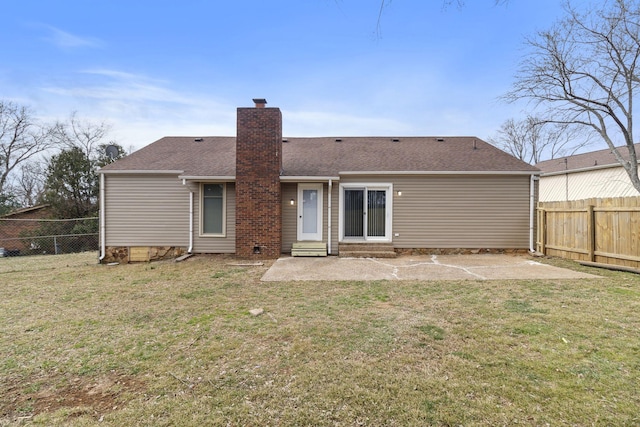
[{"left": 0, "top": 217, "right": 99, "bottom": 257}]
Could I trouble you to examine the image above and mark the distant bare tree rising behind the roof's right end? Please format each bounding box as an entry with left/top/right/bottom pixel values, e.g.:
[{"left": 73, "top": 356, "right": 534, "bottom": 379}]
[{"left": 489, "top": 116, "right": 591, "bottom": 165}]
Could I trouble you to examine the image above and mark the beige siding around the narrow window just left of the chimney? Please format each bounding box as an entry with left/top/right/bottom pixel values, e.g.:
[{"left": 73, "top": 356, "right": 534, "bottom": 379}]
[{"left": 192, "top": 182, "right": 236, "bottom": 254}]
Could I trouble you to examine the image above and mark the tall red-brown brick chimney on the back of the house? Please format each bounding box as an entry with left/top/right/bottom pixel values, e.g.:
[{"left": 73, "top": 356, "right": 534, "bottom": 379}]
[{"left": 236, "top": 99, "right": 282, "bottom": 259}]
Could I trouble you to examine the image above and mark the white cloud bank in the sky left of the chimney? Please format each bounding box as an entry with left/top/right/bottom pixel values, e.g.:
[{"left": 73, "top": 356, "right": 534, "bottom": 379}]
[{"left": 42, "top": 69, "right": 240, "bottom": 149}]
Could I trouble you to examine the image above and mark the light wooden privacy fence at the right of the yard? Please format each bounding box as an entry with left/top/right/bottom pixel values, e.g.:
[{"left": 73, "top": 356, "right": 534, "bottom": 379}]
[{"left": 536, "top": 197, "right": 640, "bottom": 269}]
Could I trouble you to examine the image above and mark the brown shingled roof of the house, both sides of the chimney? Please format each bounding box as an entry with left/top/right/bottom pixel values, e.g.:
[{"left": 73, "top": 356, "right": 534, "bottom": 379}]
[{"left": 102, "top": 137, "right": 538, "bottom": 177}]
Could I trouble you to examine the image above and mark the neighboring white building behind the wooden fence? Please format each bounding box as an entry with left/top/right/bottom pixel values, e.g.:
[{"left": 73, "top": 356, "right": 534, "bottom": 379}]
[{"left": 536, "top": 144, "right": 640, "bottom": 202}]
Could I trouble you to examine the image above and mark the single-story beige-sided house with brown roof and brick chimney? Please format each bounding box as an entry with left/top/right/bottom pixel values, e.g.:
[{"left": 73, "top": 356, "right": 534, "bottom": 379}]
[{"left": 100, "top": 100, "right": 539, "bottom": 262}]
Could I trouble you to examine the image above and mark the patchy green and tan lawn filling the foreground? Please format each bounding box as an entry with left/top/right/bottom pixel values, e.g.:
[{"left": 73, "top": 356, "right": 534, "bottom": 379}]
[{"left": 0, "top": 254, "right": 640, "bottom": 426}]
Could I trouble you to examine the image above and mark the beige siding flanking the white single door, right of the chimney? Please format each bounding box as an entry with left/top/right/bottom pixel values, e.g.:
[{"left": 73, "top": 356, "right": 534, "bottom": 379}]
[{"left": 281, "top": 182, "right": 340, "bottom": 254}]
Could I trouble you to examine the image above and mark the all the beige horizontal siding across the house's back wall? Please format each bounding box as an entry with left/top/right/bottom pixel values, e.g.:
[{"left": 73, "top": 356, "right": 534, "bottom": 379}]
[{"left": 105, "top": 174, "right": 529, "bottom": 254}]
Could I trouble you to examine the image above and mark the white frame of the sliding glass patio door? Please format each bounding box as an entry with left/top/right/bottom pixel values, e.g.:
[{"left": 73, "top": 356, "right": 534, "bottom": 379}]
[{"left": 338, "top": 182, "right": 393, "bottom": 243}]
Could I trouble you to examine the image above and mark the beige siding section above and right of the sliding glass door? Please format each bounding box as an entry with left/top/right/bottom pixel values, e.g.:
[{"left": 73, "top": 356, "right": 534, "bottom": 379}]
[{"left": 341, "top": 175, "right": 530, "bottom": 248}]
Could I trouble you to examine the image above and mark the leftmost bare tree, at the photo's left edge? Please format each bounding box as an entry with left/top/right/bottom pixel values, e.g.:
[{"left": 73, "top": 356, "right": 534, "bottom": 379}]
[{"left": 0, "top": 100, "right": 53, "bottom": 194}]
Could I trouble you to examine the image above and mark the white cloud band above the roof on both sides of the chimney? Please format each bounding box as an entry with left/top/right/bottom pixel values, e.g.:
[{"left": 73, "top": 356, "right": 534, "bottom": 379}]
[{"left": 32, "top": 62, "right": 516, "bottom": 149}]
